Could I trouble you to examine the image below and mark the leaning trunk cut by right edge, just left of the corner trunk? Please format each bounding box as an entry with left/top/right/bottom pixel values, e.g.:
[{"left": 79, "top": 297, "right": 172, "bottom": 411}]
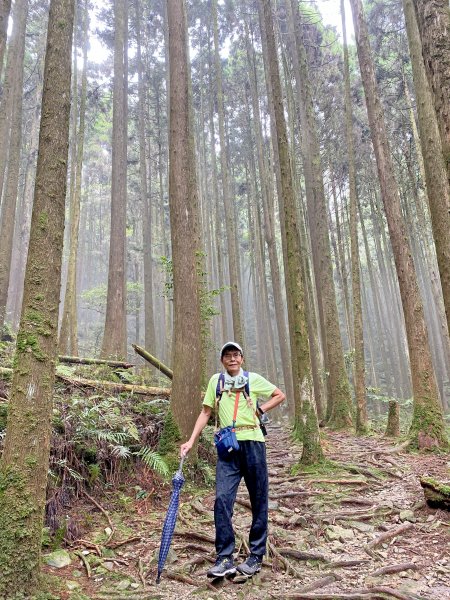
[{"left": 403, "top": 0, "right": 450, "bottom": 338}]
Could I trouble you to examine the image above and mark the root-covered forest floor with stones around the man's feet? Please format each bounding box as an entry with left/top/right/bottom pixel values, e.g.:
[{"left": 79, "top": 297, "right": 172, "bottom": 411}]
[{"left": 46, "top": 426, "right": 450, "bottom": 600}]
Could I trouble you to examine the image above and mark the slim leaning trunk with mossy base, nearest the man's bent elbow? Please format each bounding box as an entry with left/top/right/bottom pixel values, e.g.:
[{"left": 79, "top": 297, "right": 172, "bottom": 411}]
[{"left": 258, "top": 0, "right": 322, "bottom": 464}]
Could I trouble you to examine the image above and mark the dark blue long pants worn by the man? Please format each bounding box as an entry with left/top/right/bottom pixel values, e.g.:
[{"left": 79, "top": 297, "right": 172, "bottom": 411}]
[{"left": 214, "top": 441, "right": 269, "bottom": 558}]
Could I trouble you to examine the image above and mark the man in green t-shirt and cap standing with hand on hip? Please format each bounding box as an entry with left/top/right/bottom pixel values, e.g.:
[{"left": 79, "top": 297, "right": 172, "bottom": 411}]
[{"left": 181, "top": 342, "right": 286, "bottom": 577}]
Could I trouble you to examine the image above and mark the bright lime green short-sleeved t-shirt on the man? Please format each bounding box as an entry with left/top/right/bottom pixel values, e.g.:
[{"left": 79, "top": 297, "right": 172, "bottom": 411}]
[{"left": 203, "top": 373, "right": 277, "bottom": 442}]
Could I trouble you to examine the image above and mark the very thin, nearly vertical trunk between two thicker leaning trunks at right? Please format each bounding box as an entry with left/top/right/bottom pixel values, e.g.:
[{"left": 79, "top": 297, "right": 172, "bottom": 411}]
[{"left": 341, "top": 0, "right": 367, "bottom": 435}]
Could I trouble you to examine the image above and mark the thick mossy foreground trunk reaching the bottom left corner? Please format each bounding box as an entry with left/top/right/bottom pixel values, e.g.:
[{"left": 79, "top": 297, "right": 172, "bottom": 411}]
[{"left": 0, "top": 0, "right": 74, "bottom": 600}]
